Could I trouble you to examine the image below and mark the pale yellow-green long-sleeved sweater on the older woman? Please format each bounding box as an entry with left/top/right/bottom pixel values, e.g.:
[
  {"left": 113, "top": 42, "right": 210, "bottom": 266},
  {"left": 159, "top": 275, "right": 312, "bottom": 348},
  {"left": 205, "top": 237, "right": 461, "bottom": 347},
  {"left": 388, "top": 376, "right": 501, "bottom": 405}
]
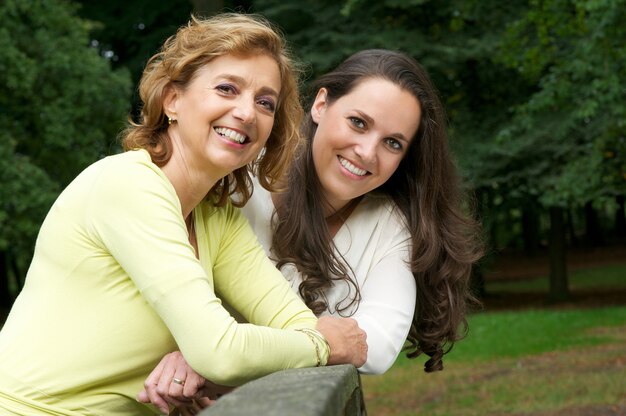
[{"left": 0, "top": 150, "right": 328, "bottom": 415}]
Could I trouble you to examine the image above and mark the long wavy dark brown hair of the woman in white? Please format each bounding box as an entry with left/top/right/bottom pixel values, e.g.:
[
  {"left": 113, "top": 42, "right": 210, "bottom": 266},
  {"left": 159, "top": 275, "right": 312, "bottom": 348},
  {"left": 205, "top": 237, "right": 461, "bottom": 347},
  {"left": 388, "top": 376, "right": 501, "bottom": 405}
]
[{"left": 272, "top": 50, "right": 482, "bottom": 372}]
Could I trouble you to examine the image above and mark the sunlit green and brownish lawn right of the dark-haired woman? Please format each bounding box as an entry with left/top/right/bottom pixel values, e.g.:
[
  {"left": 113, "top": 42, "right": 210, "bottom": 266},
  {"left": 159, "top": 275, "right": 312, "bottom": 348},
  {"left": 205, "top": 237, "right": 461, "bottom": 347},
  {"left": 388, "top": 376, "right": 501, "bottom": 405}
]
[{"left": 362, "top": 265, "right": 626, "bottom": 416}]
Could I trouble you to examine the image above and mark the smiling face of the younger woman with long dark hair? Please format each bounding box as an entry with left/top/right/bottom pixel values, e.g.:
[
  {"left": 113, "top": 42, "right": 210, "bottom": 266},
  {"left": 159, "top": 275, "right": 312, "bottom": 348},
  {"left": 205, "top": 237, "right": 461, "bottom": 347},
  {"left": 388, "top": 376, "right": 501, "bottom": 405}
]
[{"left": 311, "top": 78, "right": 420, "bottom": 210}]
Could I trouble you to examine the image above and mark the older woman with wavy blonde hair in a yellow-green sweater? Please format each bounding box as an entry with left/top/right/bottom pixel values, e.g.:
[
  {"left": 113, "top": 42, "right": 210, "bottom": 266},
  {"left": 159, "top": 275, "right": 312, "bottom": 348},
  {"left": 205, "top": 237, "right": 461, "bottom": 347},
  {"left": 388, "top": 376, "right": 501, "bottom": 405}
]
[{"left": 0, "top": 15, "right": 367, "bottom": 415}]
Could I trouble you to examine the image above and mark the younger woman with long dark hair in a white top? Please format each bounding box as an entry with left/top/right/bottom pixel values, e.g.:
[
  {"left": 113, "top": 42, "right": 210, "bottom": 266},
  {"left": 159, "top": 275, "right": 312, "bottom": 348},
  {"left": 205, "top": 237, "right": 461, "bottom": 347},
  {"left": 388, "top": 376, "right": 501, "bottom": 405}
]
[{"left": 243, "top": 50, "right": 481, "bottom": 374}]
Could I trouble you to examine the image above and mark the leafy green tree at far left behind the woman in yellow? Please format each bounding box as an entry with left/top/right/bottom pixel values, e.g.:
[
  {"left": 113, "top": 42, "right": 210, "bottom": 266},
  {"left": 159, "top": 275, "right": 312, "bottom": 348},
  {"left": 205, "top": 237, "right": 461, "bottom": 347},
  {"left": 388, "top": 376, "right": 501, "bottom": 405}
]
[{"left": 0, "top": 0, "right": 130, "bottom": 306}]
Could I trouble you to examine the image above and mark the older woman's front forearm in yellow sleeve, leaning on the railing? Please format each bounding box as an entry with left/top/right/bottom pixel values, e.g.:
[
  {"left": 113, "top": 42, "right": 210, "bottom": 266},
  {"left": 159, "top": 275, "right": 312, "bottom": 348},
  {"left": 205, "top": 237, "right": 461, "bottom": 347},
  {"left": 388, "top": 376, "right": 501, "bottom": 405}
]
[{"left": 144, "top": 276, "right": 327, "bottom": 386}]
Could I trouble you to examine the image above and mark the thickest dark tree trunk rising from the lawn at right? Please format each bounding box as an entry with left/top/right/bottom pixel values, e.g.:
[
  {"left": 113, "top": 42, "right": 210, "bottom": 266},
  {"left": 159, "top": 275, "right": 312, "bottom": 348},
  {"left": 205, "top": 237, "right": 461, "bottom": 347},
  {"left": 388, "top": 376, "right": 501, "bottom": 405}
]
[{"left": 548, "top": 207, "right": 569, "bottom": 302}]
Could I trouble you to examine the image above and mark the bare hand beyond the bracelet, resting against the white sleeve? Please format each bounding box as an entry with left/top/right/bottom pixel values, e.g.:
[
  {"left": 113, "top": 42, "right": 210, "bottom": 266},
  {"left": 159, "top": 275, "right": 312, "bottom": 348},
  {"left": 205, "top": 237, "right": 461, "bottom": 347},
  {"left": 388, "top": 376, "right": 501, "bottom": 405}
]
[{"left": 316, "top": 316, "right": 367, "bottom": 368}]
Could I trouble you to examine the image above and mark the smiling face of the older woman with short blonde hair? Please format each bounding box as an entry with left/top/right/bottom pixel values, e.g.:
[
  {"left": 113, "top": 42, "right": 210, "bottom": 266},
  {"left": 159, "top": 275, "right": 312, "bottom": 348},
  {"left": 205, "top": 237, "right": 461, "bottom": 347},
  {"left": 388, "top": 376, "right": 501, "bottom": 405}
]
[{"left": 164, "top": 55, "right": 281, "bottom": 180}]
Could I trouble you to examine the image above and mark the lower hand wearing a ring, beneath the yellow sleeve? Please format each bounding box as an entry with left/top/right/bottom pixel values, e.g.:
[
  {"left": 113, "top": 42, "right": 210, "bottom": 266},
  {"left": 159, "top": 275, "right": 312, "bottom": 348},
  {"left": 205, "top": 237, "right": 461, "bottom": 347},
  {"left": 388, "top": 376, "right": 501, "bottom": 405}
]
[{"left": 137, "top": 351, "right": 233, "bottom": 414}]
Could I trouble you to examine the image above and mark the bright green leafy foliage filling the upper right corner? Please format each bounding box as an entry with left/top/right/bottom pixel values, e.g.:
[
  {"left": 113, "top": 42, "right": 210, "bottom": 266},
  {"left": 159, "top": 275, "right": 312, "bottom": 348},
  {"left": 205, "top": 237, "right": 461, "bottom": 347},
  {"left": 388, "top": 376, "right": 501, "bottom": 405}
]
[{"left": 488, "top": 0, "right": 626, "bottom": 207}]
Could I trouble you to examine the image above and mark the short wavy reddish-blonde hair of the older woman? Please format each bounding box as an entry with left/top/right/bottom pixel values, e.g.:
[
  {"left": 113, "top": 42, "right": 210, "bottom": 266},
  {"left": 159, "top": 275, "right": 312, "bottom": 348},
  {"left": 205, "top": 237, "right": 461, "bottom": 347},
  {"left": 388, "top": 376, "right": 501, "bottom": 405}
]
[{"left": 122, "top": 13, "right": 303, "bottom": 206}]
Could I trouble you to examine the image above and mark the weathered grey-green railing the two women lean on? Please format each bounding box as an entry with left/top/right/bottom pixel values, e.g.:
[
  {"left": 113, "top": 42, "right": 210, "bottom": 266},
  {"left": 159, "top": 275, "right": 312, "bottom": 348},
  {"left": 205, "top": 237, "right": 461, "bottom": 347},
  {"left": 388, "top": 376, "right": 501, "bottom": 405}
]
[{"left": 199, "top": 365, "right": 366, "bottom": 416}]
